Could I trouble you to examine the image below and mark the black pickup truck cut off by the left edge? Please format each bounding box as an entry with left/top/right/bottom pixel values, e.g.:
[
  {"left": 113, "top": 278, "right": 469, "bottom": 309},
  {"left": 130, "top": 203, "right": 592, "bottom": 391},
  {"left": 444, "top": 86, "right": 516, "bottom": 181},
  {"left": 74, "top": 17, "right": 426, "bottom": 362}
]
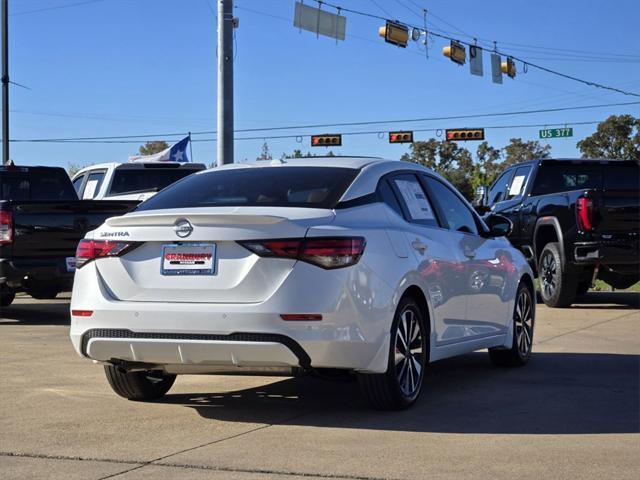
[{"left": 0, "top": 166, "right": 139, "bottom": 307}]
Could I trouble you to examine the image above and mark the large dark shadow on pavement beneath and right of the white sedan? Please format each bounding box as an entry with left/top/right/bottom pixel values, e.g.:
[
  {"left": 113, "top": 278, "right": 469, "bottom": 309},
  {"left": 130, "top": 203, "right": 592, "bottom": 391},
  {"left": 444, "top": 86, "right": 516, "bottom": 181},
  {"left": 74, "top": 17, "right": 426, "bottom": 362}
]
[{"left": 161, "top": 353, "right": 640, "bottom": 434}]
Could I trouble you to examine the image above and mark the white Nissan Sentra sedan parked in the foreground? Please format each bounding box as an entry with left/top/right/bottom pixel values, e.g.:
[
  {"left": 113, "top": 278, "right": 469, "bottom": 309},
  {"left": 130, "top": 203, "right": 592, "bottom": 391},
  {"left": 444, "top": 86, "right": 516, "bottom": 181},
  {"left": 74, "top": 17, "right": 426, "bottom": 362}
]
[{"left": 71, "top": 157, "right": 535, "bottom": 409}]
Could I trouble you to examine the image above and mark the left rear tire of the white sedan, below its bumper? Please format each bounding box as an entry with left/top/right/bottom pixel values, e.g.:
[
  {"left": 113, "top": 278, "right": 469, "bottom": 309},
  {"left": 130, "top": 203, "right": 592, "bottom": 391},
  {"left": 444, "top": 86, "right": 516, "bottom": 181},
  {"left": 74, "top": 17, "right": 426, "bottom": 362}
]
[{"left": 104, "top": 365, "right": 176, "bottom": 401}]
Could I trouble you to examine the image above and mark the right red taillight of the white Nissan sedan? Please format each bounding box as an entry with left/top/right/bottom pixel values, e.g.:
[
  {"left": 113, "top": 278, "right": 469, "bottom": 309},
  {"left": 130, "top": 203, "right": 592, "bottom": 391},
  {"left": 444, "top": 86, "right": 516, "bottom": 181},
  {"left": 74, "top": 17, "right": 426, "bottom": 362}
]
[{"left": 238, "top": 237, "right": 366, "bottom": 269}]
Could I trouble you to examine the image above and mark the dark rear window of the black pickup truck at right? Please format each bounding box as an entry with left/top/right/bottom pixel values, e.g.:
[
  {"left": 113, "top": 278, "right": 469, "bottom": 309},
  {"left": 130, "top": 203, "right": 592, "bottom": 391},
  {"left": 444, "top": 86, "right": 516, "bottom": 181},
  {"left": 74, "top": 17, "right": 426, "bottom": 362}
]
[{"left": 533, "top": 162, "right": 640, "bottom": 195}]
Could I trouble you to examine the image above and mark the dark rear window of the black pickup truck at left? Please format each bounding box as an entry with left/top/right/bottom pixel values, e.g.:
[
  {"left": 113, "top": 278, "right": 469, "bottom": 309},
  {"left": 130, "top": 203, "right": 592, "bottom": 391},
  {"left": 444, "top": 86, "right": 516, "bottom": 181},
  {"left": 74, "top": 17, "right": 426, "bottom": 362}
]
[{"left": 0, "top": 167, "right": 78, "bottom": 201}]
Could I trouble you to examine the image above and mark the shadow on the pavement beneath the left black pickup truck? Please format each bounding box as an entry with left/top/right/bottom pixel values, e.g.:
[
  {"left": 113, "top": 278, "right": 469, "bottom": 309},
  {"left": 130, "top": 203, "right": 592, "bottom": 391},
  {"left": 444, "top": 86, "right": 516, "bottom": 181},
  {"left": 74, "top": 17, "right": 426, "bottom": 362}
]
[{"left": 0, "top": 298, "right": 71, "bottom": 326}]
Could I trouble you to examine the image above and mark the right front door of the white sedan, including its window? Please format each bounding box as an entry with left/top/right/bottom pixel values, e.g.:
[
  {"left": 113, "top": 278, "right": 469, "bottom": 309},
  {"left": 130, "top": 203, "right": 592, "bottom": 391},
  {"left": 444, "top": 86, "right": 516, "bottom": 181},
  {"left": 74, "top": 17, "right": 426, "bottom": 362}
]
[{"left": 423, "top": 175, "right": 514, "bottom": 341}]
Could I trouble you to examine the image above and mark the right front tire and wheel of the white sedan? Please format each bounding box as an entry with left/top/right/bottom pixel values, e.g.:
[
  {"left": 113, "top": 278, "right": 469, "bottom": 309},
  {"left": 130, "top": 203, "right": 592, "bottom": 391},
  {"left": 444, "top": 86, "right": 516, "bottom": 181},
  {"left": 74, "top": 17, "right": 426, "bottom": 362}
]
[{"left": 489, "top": 283, "right": 536, "bottom": 367}]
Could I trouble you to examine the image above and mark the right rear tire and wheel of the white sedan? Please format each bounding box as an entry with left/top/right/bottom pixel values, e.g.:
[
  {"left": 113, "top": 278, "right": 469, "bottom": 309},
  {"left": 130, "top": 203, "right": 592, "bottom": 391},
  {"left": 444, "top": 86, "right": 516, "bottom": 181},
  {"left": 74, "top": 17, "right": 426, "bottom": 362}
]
[{"left": 358, "top": 297, "right": 429, "bottom": 410}]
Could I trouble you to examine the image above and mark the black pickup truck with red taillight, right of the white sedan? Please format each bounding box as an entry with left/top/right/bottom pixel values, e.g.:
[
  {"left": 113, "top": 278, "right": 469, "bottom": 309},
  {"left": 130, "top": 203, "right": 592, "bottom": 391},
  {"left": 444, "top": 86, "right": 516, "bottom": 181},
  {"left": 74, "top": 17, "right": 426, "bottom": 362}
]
[{"left": 475, "top": 159, "right": 640, "bottom": 307}]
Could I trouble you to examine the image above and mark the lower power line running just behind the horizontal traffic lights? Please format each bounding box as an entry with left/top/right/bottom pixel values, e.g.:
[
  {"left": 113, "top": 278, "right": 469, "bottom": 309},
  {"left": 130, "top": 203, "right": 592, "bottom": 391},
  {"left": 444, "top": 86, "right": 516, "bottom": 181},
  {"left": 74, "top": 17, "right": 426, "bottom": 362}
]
[{"left": 6, "top": 120, "right": 603, "bottom": 144}]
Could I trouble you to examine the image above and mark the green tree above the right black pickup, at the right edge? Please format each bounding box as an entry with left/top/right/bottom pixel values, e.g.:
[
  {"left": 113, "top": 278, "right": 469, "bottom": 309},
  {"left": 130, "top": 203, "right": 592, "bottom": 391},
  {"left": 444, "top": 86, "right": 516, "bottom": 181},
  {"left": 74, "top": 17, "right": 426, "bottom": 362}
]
[{"left": 577, "top": 115, "right": 640, "bottom": 160}]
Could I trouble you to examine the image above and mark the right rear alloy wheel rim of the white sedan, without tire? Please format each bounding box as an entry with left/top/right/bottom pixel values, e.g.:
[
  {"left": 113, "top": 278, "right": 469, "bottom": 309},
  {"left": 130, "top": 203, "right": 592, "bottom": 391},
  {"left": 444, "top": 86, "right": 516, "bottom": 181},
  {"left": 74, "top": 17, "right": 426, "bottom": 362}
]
[{"left": 394, "top": 308, "right": 424, "bottom": 398}]
